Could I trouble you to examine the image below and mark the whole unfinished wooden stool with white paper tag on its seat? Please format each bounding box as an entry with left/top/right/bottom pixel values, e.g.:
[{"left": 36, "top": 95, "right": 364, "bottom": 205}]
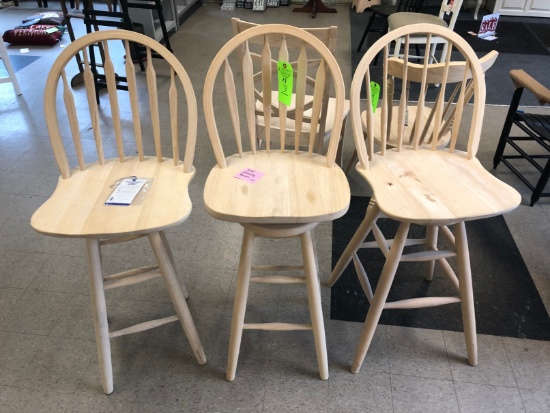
[{"left": 31, "top": 30, "right": 206, "bottom": 394}]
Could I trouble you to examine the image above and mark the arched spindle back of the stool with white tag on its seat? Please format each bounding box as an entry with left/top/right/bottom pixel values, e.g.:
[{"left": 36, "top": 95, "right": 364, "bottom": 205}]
[{"left": 44, "top": 30, "right": 197, "bottom": 178}]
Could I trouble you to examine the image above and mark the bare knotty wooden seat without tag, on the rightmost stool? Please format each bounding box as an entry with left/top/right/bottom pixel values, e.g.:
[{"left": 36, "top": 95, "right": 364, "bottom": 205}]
[{"left": 357, "top": 149, "right": 521, "bottom": 224}]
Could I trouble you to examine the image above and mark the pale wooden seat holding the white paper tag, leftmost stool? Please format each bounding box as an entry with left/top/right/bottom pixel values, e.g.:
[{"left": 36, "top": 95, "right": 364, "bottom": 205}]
[{"left": 31, "top": 157, "right": 194, "bottom": 238}]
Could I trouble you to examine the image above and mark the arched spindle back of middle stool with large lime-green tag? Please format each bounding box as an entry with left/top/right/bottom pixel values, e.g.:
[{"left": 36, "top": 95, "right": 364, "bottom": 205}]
[{"left": 203, "top": 24, "right": 345, "bottom": 167}]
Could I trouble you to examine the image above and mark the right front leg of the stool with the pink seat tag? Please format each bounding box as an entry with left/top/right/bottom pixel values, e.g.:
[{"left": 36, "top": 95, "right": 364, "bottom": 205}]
[{"left": 300, "top": 231, "right": 328, "bottom": 380}]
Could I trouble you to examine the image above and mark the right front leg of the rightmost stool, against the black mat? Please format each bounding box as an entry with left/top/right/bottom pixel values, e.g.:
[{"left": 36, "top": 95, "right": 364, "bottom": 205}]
[{"left": 454, "top": 221, "right": 477, "bottom": 366}]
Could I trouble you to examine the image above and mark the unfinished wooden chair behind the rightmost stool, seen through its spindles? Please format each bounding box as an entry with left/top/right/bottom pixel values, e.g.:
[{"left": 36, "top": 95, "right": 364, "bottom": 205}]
[{"left": 345, "top": 50, "right": 498, "bottom": 174}]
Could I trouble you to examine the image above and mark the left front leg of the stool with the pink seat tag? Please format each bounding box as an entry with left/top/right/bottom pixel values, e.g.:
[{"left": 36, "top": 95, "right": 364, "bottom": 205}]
[{"left": 226, "top": 228, "right": 255, "bottom": 381}]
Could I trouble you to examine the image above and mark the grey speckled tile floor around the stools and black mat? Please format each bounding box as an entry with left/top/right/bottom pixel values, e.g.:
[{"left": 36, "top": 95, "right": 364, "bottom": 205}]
[{"left": 0, "top": 1, "right": 550, "bottom": 413}]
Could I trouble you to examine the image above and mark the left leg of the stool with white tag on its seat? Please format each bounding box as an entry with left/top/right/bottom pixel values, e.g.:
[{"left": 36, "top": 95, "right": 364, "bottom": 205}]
[{"left": 86, "top": 239, "right": 113, "bottom": 394}]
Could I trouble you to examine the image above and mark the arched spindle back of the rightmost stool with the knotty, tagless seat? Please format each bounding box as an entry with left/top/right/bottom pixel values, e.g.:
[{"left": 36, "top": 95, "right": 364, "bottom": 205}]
[{"left": 350, "top": 24, "right": 485, "bottom": 169}]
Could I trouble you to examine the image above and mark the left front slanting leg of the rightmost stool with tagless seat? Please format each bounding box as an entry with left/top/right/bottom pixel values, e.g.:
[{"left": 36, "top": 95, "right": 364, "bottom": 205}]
[{"left": 351, "top": 222, "right": 411, "bottom": 373}]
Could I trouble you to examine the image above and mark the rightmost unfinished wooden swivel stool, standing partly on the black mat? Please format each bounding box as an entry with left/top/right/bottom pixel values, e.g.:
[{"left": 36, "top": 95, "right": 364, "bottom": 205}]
[{"left": 328, "top": 24, "right": 520, "bottom": 373}]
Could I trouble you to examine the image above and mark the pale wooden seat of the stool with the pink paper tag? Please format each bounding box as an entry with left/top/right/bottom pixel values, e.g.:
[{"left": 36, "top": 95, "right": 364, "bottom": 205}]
[{"left": 204, "top": 151, "right": 350, "bottom": 224}]
